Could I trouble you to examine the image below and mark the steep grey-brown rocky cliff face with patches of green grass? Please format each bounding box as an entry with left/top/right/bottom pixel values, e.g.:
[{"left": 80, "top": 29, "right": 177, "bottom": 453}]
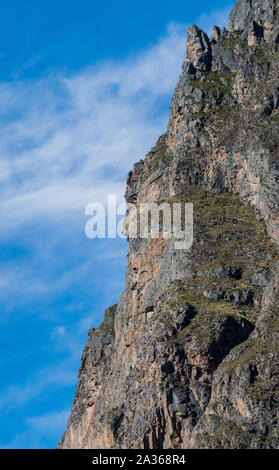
[{"left": 59, "top": 0, "right": 279, "bottom": 448}]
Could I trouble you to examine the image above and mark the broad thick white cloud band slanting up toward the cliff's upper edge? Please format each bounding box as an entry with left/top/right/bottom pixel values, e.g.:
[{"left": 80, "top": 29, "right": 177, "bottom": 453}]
[{"left": 0, "top": 26, "right": 188, "bottom": 235}]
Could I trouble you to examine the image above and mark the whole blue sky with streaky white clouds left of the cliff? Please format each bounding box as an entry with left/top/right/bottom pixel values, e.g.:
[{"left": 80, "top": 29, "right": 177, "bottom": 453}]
[{"left": 0, "top": 0, "right": 233, "bottom": 448}]
